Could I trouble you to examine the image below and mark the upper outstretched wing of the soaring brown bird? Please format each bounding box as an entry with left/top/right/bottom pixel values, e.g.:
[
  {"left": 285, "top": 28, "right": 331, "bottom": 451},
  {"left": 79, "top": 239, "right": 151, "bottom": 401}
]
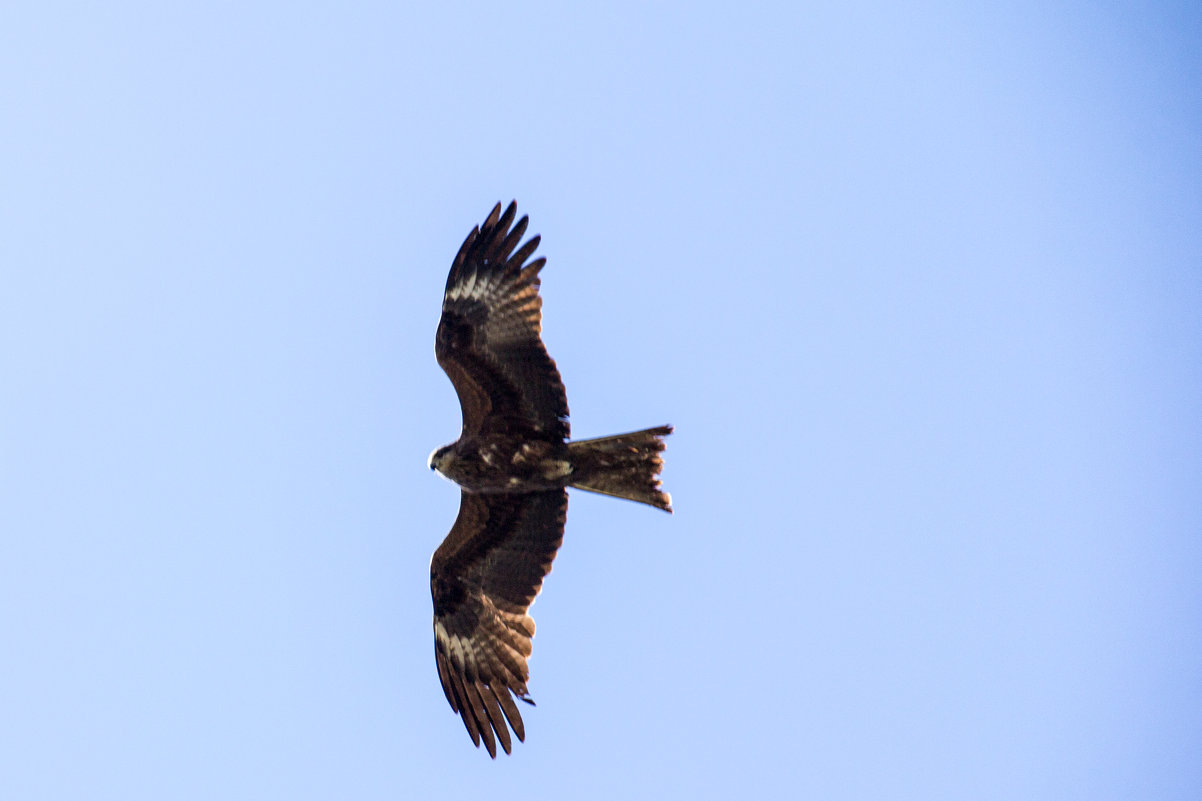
[{"left": 434, "top": 203, "right": 569, "bottom": 439}]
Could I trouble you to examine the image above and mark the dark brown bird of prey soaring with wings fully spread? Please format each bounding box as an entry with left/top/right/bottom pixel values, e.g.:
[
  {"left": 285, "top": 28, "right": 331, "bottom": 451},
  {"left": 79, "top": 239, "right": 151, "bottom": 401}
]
[{"left": 429, "top": 203, "right": 672, "bottom": 759}]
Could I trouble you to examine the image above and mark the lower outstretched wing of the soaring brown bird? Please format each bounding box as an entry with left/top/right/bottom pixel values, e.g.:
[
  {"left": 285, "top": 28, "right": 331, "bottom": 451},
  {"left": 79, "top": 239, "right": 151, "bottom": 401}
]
[{"left": 430, "top": 490, "right": 567, "bottom": 758}]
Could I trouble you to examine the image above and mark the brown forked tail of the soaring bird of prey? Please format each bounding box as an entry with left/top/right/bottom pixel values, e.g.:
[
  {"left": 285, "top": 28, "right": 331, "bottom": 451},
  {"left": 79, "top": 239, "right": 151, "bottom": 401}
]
[{"left": 567, "top": 426, "right": 672, "bottom": 512}]
